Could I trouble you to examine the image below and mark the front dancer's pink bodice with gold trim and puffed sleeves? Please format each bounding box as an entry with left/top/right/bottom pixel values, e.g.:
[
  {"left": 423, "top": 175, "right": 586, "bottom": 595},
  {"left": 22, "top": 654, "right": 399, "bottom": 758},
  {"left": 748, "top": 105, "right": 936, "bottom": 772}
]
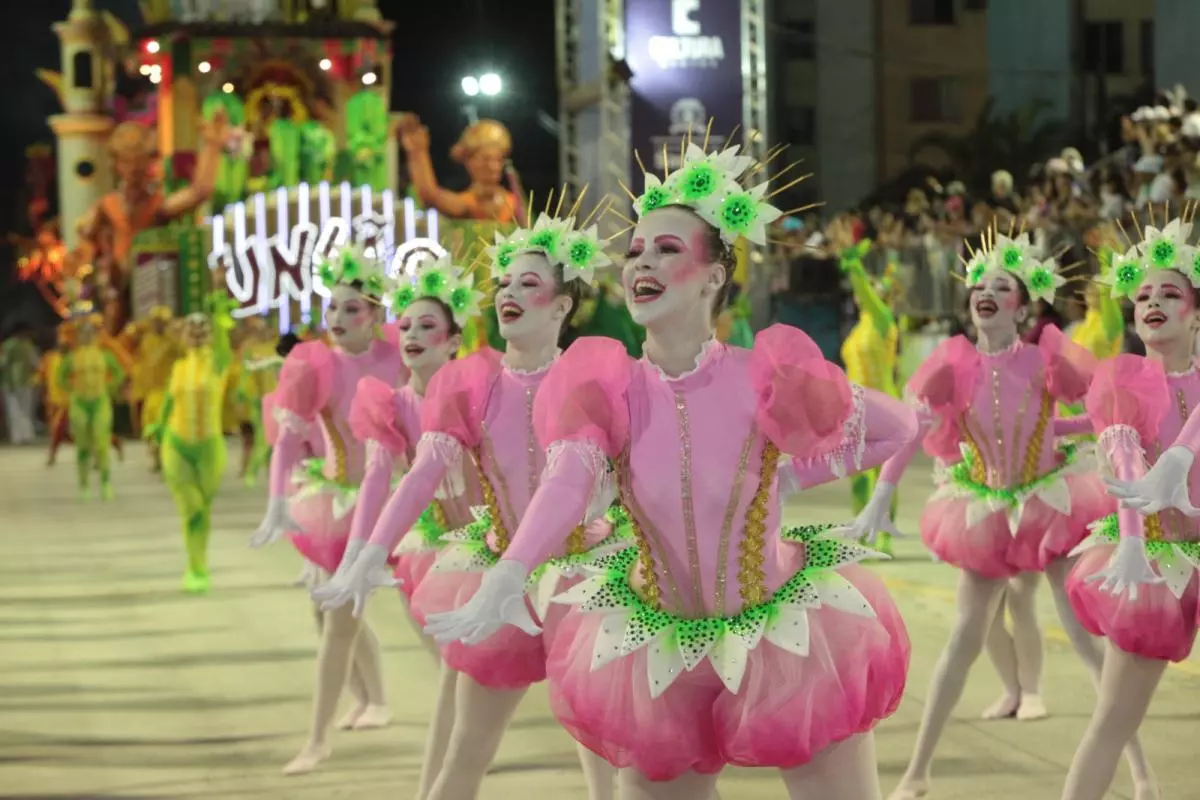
[{"left": 508, "top": 326, "right": 917, "bottom": 616}]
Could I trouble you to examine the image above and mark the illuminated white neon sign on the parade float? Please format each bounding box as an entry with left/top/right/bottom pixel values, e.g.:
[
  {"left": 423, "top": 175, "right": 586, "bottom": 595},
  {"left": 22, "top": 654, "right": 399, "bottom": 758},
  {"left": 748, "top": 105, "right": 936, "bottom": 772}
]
[{"left": 209, "top": 184, "right": 445, "bottom": 331}]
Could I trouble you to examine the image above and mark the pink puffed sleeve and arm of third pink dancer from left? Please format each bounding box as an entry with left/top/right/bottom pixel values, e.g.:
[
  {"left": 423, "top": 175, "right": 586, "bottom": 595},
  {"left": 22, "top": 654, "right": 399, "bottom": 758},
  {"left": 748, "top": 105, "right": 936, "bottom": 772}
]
[{"left": 360, "top": 349, "right": 500, "bottom": 553}]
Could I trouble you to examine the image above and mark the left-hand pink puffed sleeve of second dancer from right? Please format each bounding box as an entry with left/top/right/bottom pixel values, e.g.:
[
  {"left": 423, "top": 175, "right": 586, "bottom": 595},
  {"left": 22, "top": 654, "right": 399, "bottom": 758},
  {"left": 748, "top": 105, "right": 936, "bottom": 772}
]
[{"left": 908, "top": 336, "right": 979, "bottom": 462}]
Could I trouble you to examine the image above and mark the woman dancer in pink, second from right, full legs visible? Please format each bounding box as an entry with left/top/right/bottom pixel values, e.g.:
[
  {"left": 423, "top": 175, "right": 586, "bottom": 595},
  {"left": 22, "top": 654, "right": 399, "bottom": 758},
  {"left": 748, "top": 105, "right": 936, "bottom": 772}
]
[{"left": 851, "top": 231, "right": 1153, "bottom": 800}]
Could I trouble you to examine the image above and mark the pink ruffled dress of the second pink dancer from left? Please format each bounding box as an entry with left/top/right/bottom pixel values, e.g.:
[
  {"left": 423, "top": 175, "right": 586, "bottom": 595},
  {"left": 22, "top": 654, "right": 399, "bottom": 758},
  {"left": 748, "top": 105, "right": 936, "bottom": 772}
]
[{"left": 350, "top": 377, "right": 480, "bottom": 600}]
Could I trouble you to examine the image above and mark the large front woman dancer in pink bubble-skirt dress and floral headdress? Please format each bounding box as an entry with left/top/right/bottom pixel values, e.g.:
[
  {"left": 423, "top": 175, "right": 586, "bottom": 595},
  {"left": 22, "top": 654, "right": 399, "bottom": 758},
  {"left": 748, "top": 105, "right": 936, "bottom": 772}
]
[{"left": 427, "top": 145, "right": 918, "bottom": 800}]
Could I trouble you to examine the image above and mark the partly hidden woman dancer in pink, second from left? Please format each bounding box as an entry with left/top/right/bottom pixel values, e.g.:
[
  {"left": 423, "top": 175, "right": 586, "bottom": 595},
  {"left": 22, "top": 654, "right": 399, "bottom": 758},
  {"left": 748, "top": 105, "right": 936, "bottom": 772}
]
[{"left": 343, "top": 258, "right": 482, "bottom": 800}]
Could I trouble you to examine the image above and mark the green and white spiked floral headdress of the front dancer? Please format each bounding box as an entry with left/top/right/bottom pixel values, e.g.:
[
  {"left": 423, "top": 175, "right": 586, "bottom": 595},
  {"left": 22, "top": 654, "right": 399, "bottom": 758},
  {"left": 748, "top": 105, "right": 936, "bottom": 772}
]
[{"left": 634, "top": 143, "right": 784, "bottom": 245}]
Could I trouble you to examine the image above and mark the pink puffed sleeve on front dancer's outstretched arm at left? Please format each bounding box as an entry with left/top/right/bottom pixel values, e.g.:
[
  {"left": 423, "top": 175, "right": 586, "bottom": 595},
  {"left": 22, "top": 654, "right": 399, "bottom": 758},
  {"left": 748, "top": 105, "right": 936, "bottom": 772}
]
[{"left": 504, "top": 336, "right": 631, "bottom": 570}]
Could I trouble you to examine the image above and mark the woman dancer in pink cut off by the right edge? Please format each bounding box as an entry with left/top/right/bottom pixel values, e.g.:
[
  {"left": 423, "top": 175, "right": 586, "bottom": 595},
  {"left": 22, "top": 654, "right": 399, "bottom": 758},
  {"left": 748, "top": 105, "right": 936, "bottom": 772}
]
[{"left": 1062, "top": 214, "right": 1200, "bottom": 800}]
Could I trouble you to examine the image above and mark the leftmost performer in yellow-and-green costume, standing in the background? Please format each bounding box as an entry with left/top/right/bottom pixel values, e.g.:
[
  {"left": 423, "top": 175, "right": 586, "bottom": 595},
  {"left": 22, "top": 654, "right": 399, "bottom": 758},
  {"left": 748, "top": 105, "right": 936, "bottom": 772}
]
[{"left": 59, "top": 314, "right": 125, "bottom": 500}]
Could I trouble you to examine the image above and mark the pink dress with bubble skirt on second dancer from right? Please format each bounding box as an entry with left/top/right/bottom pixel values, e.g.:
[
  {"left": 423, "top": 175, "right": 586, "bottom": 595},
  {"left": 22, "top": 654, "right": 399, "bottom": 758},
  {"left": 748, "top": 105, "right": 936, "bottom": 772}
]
[{"left": 907, "top": 325, "right": 1116, "bottom": 578}]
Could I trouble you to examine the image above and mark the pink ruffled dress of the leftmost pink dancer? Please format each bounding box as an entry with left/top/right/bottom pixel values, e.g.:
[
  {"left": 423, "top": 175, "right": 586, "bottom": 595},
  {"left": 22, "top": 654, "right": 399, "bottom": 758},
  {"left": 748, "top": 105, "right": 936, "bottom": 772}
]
[{"left": 270, "top": 341, "right": 407, "bottom": 572}]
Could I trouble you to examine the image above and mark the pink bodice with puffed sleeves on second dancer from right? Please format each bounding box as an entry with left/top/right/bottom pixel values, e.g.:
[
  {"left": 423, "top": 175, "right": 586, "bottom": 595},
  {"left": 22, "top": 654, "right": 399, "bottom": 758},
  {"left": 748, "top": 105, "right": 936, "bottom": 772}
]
[{"left": 908, "top": 326, "right": 1094, "bottom": 488}]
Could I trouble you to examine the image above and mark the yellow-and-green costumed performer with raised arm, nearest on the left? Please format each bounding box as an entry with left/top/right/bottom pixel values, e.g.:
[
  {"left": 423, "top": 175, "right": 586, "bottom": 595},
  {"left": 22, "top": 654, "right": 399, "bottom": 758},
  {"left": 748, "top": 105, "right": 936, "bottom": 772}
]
[{"left": 145, "top": 295, "right": 233, "bottom": 594}]
